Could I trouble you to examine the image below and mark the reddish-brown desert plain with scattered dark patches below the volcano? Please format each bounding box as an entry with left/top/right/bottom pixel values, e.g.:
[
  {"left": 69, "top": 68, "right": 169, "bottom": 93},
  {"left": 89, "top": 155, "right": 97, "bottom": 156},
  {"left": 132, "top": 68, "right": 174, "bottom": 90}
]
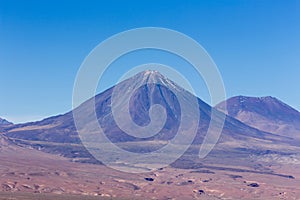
[{"left": 0, "top": 139, "right": 300, "bottom": 200}]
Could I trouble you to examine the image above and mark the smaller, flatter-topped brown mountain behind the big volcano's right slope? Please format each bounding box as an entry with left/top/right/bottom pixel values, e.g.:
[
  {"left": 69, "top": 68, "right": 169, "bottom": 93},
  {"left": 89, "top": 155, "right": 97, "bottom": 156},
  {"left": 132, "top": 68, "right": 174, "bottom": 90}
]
[{"left": 215, "top": 96, "right": 300, "bottom": 138}]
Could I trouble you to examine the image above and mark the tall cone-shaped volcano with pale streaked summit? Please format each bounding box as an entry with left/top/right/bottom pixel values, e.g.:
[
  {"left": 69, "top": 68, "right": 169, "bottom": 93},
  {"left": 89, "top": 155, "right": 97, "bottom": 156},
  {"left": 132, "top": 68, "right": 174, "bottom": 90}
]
[{"left": 4, "top": 70, "right": 298, "bottom": 167}]
